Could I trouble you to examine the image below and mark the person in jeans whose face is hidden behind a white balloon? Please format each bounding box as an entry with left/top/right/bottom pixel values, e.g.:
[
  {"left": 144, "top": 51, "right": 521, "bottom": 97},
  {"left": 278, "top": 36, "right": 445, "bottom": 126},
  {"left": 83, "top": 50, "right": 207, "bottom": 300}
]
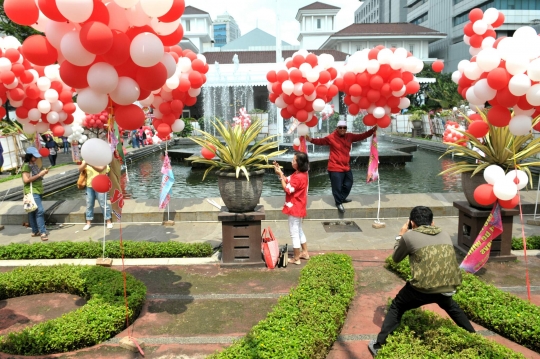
[{"left": 79, "top": 160, "right": 113, "bottom": 231}]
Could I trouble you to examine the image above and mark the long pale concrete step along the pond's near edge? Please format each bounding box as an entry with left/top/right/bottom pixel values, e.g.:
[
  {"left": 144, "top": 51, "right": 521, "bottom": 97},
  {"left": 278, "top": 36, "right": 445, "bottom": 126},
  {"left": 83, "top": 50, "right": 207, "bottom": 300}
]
[{"left": 0, "top": 191, "right": 536, "bottom": 225}]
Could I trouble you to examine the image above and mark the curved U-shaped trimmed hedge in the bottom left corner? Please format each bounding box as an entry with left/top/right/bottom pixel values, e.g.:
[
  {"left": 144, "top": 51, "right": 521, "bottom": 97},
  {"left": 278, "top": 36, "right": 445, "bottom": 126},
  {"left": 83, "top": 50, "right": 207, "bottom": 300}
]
[{"left": 0, "top": 265, "right": 146, "bottom": 355}]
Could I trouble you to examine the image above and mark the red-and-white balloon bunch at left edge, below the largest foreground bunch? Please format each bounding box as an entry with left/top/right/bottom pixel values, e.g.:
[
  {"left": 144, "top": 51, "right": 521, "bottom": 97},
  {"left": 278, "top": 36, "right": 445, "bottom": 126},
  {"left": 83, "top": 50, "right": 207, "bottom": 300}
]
[{"left": 0, "top": 36, "right": 76, "bottom": 136}]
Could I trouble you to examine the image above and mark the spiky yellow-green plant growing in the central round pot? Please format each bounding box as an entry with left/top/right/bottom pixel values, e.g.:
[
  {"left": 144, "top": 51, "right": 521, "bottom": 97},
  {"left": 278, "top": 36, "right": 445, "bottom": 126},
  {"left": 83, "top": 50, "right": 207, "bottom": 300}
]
[{"left": 191, "top": 120, "right": 287, "bottom": 181}]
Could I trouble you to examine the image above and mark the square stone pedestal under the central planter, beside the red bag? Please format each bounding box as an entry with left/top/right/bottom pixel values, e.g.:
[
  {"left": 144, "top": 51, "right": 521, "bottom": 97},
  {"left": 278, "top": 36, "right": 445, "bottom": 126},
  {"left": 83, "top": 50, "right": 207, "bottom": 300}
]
[{"left": 218, "top": 205, "right": 266, "bottom": 267}]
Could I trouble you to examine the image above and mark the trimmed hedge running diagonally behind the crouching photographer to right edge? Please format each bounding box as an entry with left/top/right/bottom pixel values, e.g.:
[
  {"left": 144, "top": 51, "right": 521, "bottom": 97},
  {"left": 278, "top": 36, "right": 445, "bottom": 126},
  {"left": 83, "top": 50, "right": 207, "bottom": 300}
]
[{"left": 386, "top": 256, "right": 540, "bottom": 352}]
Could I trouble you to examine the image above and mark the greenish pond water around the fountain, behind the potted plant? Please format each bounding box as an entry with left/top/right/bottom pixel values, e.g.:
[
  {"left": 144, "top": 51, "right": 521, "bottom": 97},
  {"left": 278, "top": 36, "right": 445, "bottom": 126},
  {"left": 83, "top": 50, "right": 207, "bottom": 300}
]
[{"left": 45, "top": 149, "right": 462, "bottom": 200}]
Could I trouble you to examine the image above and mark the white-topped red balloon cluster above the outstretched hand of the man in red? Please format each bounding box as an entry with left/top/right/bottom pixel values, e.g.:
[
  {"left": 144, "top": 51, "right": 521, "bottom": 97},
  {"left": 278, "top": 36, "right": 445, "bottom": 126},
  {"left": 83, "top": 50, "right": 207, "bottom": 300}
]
[{"left": 335, "top": 45, "right": 424, "bottom": 128}]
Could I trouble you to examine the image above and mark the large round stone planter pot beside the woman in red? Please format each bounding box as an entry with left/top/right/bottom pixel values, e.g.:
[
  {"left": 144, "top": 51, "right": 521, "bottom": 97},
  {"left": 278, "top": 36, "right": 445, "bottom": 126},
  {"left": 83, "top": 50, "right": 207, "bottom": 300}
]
[{"left": 217, "top": 169, "right": 265, "bottom": 213}]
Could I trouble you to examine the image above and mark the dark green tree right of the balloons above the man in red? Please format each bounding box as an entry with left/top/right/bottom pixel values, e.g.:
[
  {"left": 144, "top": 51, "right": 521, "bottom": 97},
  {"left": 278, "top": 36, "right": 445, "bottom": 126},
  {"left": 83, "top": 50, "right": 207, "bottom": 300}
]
[{"left": 409, "top": 67, "right": 463, "bottom": 110}]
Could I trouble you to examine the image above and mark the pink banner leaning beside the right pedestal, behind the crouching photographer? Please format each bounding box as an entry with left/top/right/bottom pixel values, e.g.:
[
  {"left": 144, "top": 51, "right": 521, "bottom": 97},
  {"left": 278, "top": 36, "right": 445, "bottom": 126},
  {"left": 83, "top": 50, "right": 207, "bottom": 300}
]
[{"left": 459, "top": 202, "right": 503, "bottom": 273}]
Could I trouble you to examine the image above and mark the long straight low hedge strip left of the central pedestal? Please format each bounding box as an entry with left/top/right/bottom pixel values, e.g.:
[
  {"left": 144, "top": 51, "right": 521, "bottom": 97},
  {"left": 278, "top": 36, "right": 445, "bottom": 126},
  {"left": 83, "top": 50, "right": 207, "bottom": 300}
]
[{"left": 0, "top": 241, "right": 212, "bottom": 259}]
